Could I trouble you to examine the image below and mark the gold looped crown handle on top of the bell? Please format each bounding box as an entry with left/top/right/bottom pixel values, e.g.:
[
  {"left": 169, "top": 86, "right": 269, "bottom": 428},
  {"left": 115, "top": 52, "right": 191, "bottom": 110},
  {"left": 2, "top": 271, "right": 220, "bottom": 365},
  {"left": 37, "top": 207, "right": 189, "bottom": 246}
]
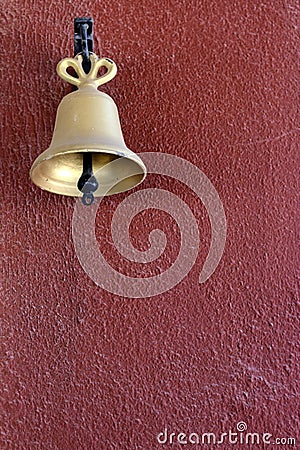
[{"left": 56, "top": 52, "right": 117, "bottom": 88}]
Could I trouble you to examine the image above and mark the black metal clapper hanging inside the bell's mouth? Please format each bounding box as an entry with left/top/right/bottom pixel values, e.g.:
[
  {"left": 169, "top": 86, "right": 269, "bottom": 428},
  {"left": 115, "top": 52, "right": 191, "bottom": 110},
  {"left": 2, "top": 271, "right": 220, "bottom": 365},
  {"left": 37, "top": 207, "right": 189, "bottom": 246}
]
[{"left": 77, "top": 152, "right": 99, "bottom": 206}]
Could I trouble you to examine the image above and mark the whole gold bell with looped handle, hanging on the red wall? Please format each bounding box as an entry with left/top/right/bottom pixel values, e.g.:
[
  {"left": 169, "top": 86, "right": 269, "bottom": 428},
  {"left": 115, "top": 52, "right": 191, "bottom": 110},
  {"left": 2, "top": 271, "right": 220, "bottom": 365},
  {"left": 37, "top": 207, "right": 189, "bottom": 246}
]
[{"left": 30, "top": 52, "right": 146, "bottom": 204}]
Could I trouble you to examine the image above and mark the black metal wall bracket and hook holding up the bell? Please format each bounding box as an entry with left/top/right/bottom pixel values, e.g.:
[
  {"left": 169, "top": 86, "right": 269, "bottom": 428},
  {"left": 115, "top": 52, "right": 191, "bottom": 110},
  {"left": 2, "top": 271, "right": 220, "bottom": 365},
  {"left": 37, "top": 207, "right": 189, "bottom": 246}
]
[{"left": 74, "top": 17, "right": 94, "bottom": 73}]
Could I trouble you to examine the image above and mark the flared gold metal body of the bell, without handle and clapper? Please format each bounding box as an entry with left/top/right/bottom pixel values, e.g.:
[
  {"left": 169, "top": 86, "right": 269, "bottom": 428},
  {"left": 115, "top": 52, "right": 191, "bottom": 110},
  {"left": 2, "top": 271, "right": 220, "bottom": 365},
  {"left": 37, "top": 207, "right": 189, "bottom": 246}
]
[{"left": 30, "top": 52, "right": 146, "bottom": 196}]
